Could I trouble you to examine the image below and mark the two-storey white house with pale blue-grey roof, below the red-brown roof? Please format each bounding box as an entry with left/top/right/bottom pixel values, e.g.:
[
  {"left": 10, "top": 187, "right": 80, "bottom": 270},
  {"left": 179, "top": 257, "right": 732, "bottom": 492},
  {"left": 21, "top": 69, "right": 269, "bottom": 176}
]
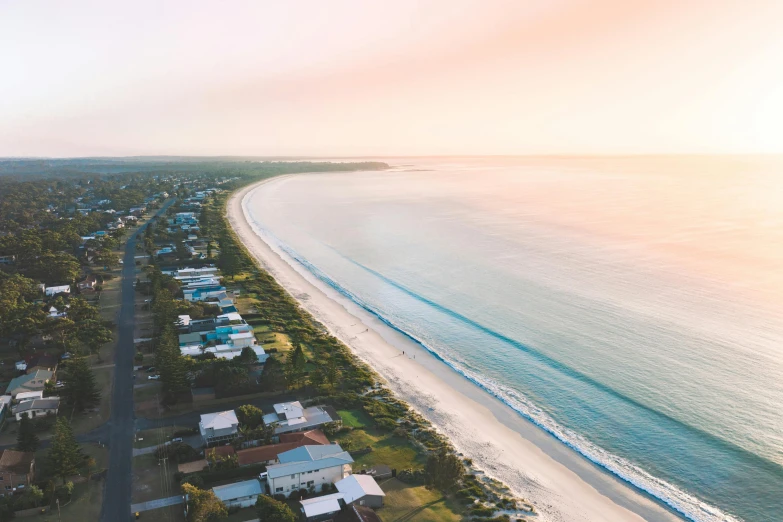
[{"left": 266, "top": 444, "right": 353, "bottom": 496}]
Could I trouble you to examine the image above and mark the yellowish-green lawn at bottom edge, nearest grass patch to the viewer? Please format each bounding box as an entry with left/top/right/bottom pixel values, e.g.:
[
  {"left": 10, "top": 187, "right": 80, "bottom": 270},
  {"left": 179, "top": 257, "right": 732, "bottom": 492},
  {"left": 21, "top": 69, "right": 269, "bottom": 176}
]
[{"left": 378, "top": 479, "right": 463, "bottom": 522}]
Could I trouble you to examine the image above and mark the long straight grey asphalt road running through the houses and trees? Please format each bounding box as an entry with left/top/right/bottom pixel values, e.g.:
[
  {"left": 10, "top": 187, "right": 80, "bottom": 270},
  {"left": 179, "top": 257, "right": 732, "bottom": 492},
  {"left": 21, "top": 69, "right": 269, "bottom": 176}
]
[{"left": 101, "top": 199, "right": 174, "bottom": 522}]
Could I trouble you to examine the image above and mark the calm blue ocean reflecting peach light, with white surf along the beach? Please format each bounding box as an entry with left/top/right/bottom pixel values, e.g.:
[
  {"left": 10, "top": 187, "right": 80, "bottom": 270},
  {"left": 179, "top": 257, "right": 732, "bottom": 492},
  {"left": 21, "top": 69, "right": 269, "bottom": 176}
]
[{"left": 246, "top": 156, "right": 783, "bottom": 522}]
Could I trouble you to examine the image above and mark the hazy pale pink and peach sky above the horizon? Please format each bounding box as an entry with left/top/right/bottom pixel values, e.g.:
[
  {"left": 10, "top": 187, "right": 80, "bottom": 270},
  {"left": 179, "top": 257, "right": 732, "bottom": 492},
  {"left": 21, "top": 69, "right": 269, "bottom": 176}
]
[{"left": 0, "top": 0, "right": 783, "bottom": 156}]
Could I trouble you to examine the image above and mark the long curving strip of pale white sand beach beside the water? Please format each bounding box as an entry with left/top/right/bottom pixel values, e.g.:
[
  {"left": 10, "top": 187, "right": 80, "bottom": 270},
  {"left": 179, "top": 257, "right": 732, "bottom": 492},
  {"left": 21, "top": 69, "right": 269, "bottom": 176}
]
[{"left": 228, "top": 177, "right": 680, "bottom": 522}]
